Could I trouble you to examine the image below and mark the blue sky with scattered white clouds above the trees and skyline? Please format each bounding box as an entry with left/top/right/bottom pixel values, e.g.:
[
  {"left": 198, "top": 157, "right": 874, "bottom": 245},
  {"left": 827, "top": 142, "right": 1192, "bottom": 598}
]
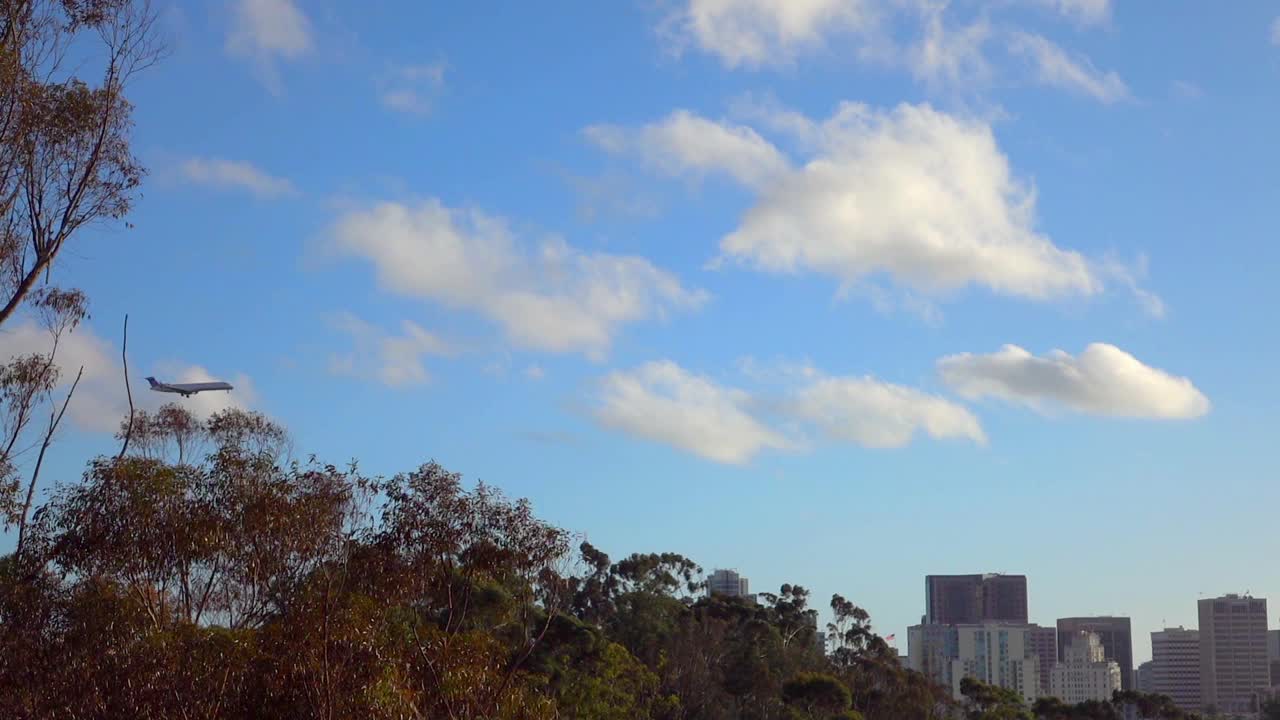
[{"left": 4, "top": 0, "right": 1280, "bottom": 657}]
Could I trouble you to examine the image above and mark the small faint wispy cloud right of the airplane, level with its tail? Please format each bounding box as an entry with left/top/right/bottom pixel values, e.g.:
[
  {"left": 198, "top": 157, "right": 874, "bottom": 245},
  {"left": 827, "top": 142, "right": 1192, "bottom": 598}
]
[{"left": 329, "top": 313, "right": 454, "bottom": 387}]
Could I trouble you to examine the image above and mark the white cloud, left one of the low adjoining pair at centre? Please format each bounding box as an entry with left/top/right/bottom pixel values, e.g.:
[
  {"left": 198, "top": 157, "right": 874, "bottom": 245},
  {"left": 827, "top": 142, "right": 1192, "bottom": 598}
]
[{"left": 595, "top": 361, "right": 792, "bottom": 465}]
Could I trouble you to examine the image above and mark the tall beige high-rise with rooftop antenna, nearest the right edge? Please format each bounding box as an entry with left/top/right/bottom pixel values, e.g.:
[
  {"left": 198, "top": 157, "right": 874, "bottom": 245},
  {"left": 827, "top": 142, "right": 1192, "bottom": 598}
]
[{"left": 1199, "top": 594, "right": 1271, "bottom": 715}]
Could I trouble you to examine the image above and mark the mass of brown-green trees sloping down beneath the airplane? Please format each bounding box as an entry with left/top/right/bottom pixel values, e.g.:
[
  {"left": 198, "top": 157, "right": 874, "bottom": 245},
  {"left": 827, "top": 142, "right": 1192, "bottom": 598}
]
[{"left": 0, "top": 406, "right": 956, "bottom": 720}]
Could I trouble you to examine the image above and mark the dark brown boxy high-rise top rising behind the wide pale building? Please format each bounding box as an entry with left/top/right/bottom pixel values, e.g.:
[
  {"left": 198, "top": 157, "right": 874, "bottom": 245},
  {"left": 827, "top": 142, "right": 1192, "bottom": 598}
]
[{"left": 924, "top": 574, "right": 1027, "bottom": 625}]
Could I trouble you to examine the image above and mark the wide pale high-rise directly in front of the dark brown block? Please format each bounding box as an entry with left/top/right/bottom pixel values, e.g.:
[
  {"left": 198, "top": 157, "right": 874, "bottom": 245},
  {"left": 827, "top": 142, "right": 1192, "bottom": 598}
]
[{"left": 908, "top": 623, "right": 1052, "bottom": 702}]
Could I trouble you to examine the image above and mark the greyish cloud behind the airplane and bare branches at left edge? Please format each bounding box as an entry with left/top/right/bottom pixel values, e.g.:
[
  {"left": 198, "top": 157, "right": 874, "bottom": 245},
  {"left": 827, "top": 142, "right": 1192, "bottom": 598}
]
[{"left": 0, "top": 322, "right": 257, "bottom": 433}]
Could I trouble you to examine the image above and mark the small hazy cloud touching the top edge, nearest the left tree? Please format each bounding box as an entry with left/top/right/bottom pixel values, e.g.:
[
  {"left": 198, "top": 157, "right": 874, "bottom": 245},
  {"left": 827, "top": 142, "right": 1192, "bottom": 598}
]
[{"left": 227, "top": 0, "right": 312, "bottom": 92}]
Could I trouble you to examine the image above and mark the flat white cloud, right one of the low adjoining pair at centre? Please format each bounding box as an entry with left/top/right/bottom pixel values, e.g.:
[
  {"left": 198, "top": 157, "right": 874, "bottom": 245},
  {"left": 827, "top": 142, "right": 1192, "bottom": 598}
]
[{"left": 791, "top": 377, "right": 987, "bottom": 447}]
